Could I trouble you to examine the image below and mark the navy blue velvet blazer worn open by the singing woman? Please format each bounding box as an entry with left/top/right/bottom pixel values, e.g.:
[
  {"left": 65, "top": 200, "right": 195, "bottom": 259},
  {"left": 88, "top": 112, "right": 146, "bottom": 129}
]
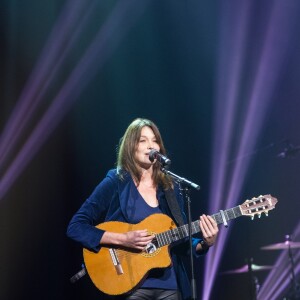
[{"left": 67, "top": 169, "right": 203, "bottom": 299}]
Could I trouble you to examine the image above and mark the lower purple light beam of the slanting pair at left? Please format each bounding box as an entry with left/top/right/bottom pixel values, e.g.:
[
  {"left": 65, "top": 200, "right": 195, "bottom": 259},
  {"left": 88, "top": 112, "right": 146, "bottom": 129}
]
[{"left": 0, "top": 0, "right": 149, "bottom": 200}]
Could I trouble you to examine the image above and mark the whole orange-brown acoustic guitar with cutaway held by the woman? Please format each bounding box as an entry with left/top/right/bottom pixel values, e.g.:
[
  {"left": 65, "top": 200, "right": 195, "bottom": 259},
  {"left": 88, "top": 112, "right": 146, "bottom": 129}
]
[{"left": 83, "top": 195, "right": 277, "bottom": 295}]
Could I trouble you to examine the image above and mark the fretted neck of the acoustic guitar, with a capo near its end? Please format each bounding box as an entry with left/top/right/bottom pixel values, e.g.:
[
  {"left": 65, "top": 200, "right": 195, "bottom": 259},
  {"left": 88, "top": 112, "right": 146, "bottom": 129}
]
[{"left": 156, "top": 206, "right": 242, "bottom": 247}]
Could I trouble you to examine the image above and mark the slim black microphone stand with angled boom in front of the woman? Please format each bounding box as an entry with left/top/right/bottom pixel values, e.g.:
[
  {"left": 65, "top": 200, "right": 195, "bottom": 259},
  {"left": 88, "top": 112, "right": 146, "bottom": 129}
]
[{"left": 161, "top": 166, "right": 200, "bottom": 300}]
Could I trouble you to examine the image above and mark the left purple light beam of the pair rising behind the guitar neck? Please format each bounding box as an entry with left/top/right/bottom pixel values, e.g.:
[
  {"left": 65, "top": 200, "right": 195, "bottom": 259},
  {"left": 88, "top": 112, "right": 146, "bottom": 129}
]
[{"left": 202, "top": 2, "right": 253, "bottom": 300}]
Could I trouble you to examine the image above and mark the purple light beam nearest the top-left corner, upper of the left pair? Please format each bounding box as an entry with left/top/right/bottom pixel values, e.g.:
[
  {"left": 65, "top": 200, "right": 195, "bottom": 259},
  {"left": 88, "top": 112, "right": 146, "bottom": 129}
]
[{"left": 0, "top": 0, "right": 95, "bottom": 170}]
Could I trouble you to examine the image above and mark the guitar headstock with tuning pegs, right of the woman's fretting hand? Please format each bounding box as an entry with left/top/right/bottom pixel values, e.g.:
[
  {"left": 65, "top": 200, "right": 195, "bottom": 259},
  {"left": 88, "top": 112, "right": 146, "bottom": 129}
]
[{"left": 240, "top": 195, "right": 278, "bottom": 220}]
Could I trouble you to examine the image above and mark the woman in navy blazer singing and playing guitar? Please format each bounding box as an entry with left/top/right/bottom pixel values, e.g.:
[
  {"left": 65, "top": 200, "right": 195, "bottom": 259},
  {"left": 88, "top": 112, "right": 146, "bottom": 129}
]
[{"left": 67, "top": 119, "right": 218, "bottom": 300}]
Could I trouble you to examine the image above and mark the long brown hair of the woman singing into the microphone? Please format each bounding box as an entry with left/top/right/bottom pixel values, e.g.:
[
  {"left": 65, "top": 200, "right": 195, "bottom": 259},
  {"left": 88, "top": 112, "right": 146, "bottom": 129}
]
[{"left": 116, "top": 118, "right": 173, "bottom": 189}]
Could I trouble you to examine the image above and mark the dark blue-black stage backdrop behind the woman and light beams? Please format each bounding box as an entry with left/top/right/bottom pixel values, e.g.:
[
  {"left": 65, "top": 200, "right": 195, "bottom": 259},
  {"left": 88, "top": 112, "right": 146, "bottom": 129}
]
[{"left": 0, "top": 0, "right": 300, "bottom": 299}]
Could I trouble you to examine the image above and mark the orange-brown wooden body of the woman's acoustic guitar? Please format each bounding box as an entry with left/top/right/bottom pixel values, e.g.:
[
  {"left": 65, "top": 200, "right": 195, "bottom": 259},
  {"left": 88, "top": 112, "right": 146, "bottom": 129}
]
[{"left": 83, "top": 214, "right": 176, "bottom": 295}]
